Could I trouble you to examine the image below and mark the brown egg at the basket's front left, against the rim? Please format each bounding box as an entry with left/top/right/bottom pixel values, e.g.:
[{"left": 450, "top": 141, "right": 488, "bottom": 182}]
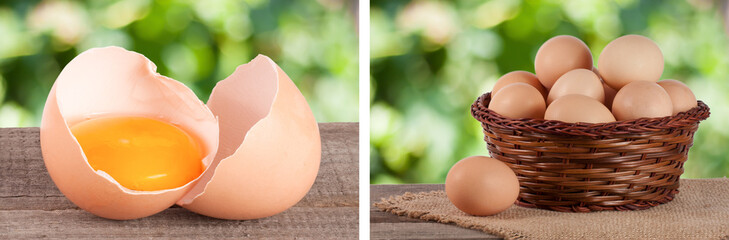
[{"left": 489, "top": 83, "right": 547, "bottom": 118}]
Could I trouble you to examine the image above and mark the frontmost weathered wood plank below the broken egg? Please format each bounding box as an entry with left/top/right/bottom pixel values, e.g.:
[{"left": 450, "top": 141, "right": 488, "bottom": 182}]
[{"left": 0, "top": 206, "right": 357, "bottom": 239}]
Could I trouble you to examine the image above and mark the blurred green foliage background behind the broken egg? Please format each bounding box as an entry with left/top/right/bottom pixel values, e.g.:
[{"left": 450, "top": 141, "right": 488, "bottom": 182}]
[{"left": 0, "top": 0, "right": 358, "bottom": 127}]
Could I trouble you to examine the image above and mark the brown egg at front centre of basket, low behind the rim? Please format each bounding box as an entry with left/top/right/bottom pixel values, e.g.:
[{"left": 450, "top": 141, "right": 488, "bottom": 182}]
[{"left": 544, "top": 94, "right": 615, "bottom": 123}]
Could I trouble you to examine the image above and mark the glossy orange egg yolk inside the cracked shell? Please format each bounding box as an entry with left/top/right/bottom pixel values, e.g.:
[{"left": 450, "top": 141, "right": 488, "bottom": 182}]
[{"left": 71, "top": 117, "right": 205, "bottom": 191}]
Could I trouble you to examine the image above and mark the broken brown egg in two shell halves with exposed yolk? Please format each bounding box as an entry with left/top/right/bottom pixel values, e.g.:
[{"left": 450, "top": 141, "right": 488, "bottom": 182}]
[{"left": 40, "top": 47, "right": 321, "bottom": 220}]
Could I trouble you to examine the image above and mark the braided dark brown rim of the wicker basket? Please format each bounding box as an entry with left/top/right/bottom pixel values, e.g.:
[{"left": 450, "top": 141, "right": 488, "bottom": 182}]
[{"left": 471, "top": 92, "right": 710, "bottom": 137}]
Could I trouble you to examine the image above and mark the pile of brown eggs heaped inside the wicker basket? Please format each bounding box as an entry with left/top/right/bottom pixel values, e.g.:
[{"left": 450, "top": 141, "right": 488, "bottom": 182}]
[{"left": 488, "top": 35, "right": 697, "bottom": 123}]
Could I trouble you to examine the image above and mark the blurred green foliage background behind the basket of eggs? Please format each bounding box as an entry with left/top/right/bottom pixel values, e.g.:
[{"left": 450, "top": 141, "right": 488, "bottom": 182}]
[{"left": 370, "top": 0, "right": 729, "bottom": 184}]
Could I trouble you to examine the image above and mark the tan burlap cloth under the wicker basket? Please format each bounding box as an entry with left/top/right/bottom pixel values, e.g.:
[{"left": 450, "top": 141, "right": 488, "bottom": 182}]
[{"left": 375, "top": 178, "right": 729, "bottom": 239}]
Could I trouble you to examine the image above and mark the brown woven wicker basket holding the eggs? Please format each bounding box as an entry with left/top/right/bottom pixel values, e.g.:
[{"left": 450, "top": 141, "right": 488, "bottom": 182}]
[{"left": 471, "top": 93, "right": 709, "bottom": 212}]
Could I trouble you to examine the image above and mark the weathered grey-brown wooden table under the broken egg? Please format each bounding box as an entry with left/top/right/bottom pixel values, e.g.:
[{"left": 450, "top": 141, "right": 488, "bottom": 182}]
[{"left": 0, "top": 123, "right": 359, "bottom": 239}]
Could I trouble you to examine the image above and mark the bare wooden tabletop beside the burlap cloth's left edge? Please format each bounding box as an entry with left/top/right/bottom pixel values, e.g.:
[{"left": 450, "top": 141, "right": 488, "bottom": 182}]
[{"left": 370, "top": 184, "right": 501, "bottom": 239}]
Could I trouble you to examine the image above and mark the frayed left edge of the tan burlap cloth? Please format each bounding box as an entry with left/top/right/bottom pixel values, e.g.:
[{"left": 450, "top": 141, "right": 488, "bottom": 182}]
[{"left": 374, "top": 191, "right": 527, "bottom": 239}]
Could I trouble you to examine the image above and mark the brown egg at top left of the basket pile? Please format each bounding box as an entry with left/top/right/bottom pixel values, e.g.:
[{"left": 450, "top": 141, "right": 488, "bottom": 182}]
[{"left": 534, "top": 35, "right": 592, "bottom": 89}]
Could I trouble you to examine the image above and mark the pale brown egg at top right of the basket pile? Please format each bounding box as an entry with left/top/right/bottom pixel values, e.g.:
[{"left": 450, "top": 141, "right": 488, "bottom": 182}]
[{"left": 597, "top": 35, "right": 663, "bottom": 90}]
